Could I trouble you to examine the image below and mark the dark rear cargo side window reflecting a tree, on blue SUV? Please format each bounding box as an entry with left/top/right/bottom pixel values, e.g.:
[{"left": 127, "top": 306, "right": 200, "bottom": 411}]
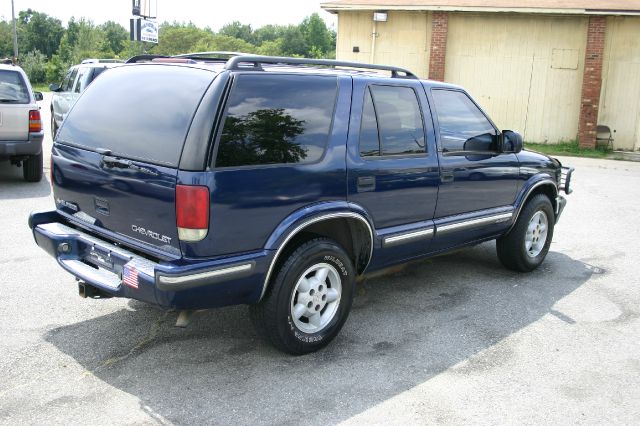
[{"left": 216, "top": 74, "right": 337, "bottom": 167}]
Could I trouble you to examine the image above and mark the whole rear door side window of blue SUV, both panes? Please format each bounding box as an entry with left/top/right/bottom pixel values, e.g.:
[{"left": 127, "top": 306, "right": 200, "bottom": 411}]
[{"left": 360, "top": 86, "right": 426, "bottom": 157}]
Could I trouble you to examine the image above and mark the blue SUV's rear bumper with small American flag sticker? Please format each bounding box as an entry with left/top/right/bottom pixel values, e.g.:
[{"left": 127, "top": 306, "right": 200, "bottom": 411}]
[{"left": 29, "top": 211, "right": 272, "bottom": 309}]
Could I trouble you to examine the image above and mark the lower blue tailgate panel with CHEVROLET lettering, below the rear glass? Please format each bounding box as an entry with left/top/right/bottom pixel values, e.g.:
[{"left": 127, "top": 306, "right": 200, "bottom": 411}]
[{"left": 52, "top": 144, "right": 180, "bottom": 256}]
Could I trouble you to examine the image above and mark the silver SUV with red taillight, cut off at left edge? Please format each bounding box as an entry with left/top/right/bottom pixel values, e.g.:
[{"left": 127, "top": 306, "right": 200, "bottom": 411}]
[{"left": 0, "top": 64, "right": 44, "bottom": 182}]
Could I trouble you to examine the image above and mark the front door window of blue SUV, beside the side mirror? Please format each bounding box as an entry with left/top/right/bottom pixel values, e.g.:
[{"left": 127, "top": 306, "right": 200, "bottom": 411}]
[{"left": 433, "top": 90, "right": 497, "bottom": 152}]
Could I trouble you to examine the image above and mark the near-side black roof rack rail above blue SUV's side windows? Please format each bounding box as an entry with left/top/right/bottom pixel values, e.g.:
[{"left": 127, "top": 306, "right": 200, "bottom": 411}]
[{"left": 225, "top": 55, "right": 418, "bottom": 79}]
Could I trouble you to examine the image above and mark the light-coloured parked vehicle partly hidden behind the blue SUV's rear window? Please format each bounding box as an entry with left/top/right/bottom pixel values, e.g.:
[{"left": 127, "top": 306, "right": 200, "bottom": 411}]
[{"left": 49, "top": 59, "right": 122, "bottom": 137}]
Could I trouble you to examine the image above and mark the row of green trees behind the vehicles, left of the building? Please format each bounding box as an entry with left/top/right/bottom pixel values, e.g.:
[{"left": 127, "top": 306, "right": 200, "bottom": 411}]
[{"left": 0, "top": 9, "right": 336, "bottom": 84}]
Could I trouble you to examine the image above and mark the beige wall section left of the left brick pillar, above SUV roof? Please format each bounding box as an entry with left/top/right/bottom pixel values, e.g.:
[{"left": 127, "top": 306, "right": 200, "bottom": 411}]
[{"left": 336, "top": 12, "right": 431, "bottom": 78}]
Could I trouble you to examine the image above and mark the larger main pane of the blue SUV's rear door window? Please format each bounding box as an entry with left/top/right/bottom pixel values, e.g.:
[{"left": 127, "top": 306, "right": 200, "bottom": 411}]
[{"left": 371, "top": 86, "right": 425, "bottom": 155}]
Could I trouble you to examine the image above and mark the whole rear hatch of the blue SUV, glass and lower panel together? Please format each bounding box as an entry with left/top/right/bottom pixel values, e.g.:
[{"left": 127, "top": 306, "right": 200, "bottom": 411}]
[{"left": 52, "top": 65, "right": 215, "bottom": 256}]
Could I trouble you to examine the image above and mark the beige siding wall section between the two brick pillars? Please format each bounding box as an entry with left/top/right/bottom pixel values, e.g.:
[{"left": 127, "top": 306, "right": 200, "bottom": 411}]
[{"left": 445, "top": 14, "right": 588, "bottom": 143}]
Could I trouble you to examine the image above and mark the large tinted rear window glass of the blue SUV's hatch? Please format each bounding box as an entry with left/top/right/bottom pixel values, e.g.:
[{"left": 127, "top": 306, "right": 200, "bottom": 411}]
[{"left": 57, "top": 65, "right": 215, "bottom": 167}]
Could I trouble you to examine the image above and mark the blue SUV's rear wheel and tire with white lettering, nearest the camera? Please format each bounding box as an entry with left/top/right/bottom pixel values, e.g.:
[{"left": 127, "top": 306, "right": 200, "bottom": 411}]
[{"left": 249, "top": 238, "right": 355, "bottom": 355}]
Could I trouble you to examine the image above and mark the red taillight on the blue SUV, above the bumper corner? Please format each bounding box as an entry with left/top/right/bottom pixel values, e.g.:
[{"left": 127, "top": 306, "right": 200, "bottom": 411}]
[{"left": 176, "top": 185, "right": 209, "bottom": 241}]
